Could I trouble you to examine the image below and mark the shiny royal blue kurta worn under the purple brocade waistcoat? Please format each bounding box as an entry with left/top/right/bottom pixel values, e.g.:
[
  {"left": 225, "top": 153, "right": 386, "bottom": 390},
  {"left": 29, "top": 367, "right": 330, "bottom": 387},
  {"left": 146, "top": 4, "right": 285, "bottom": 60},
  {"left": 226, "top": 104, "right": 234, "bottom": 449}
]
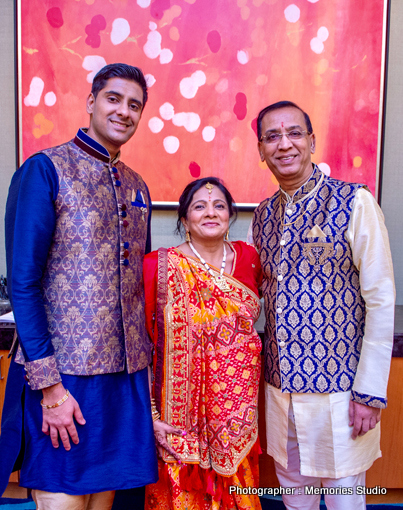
[{"left": 0, "top": 130, "right": 158, "bottom": 494}]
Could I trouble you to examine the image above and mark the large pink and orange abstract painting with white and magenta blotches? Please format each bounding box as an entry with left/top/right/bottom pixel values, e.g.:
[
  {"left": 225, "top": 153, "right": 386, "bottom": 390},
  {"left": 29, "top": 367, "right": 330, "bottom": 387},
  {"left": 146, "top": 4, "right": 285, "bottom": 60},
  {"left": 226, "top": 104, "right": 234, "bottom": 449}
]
[{"left": 18, "top": 0, "right": 386, "bottom": 204}]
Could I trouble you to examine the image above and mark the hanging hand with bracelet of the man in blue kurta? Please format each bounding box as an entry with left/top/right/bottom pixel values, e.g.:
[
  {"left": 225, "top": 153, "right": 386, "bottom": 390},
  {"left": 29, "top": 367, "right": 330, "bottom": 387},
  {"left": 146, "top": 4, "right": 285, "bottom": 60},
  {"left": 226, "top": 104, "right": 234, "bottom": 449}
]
[{"left": 42, "top": 383, "right": 85, "bottom": 451}]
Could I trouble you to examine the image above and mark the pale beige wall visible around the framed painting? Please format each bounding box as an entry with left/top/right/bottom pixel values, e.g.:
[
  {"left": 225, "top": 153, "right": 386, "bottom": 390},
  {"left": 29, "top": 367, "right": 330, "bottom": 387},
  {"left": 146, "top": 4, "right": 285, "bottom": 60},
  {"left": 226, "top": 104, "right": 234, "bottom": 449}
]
[{"left": 0, "top": 0, "right": 403, "bottom": 305}]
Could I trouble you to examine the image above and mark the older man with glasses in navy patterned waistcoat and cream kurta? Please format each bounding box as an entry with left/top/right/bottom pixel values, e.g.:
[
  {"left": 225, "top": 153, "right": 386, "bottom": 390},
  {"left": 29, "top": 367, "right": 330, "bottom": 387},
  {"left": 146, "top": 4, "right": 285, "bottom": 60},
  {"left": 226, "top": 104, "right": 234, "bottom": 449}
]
[{"left": 252, "top": 101, "right": 394, "bottom": 510}]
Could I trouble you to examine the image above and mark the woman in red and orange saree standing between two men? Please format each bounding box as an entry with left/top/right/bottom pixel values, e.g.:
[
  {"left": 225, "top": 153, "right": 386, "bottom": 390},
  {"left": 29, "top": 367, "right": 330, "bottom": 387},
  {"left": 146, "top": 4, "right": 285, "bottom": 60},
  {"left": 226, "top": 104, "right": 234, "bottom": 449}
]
[{"left": 144, "top": 177, "right": 261, "bottom": 510}]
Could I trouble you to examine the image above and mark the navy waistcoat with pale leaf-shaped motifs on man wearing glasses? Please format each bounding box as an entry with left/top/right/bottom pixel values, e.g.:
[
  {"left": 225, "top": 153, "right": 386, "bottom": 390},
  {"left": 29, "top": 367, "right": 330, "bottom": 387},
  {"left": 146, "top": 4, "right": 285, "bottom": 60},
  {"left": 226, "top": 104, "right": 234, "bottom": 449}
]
[{"left": 253, "top": 167, "right": 365, "bottom": 393}]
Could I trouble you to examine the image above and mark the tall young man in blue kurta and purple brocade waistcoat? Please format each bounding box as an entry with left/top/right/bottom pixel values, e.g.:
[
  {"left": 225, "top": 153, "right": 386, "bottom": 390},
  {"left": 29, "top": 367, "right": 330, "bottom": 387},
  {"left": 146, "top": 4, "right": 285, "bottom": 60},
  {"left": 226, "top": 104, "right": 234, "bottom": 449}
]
[{"left": 1, "top": 64, "right": 157, "bottom": 510}]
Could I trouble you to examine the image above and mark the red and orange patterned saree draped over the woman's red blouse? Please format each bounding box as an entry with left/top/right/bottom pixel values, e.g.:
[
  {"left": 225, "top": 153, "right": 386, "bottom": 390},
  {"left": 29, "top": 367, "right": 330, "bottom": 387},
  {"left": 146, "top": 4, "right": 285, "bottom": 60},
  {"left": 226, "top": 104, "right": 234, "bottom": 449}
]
[{"left": 146, "top": 248, "right": 262, "bottom": 510}]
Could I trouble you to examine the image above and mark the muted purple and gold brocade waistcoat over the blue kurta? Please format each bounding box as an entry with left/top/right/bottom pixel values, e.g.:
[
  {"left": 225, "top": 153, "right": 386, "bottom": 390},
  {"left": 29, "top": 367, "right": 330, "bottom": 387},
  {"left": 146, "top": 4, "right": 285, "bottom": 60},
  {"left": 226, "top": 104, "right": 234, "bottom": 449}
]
[{"left": 33, "top": 132, "right": 151, "bottom": 375}]
